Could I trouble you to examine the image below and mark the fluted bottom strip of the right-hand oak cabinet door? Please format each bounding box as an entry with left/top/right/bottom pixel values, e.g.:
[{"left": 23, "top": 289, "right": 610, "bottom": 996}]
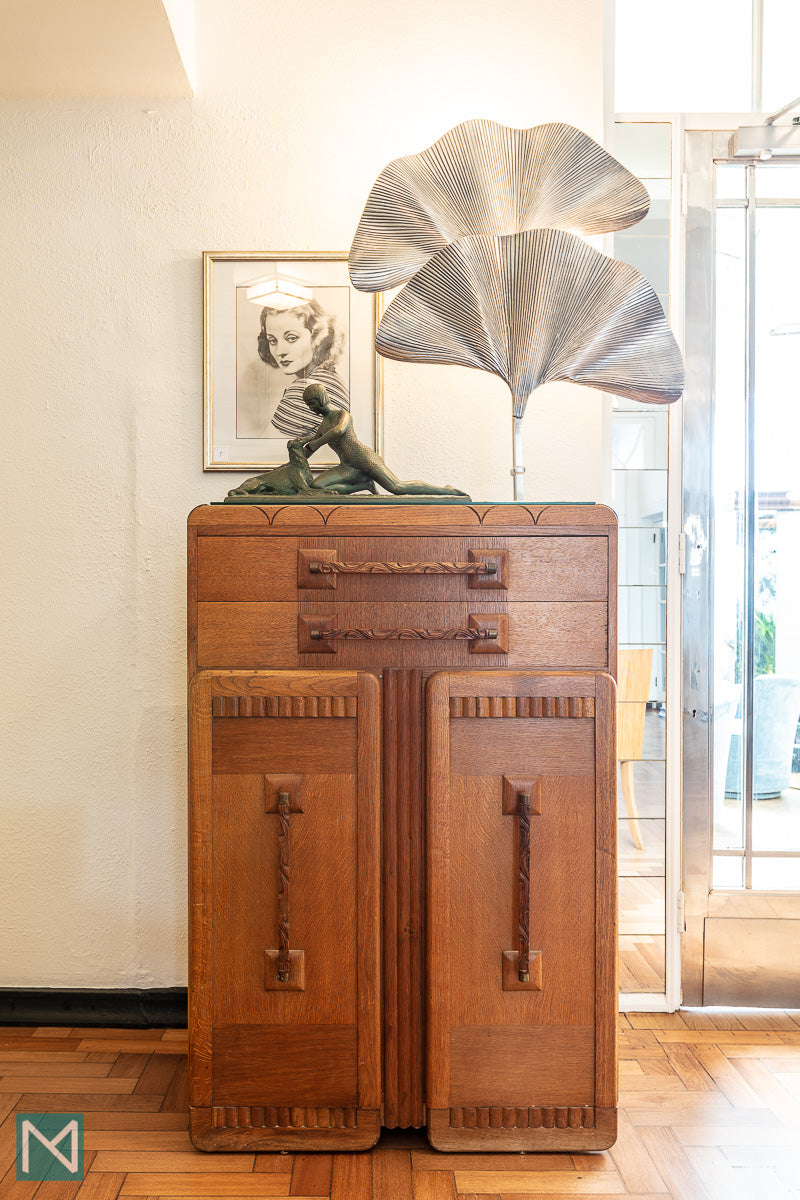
[{"left": 428, "top": 1108, "right": 616, "bottom": 1153}]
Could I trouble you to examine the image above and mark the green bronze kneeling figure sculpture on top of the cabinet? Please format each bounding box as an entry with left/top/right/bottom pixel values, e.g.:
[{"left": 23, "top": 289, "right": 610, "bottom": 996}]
[{"left": 228, "top": 383, "right": 469, "bottom": 499}]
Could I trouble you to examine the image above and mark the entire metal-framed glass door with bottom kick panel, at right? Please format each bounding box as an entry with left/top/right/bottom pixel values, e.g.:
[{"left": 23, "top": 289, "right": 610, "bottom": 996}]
[{"left": 684, "top": 133, "right": 800, "bottom": 1004}]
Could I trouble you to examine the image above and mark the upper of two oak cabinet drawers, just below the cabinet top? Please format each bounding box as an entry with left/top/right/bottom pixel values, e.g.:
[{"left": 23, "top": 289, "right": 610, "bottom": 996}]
[{"left": 198, "top": 536, "right": 608, "bottom": 604}]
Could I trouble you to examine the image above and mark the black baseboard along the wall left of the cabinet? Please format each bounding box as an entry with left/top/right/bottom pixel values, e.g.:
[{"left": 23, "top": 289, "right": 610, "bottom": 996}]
[{"left": 0, "top": 988, "right": 188, "bottom": 1030}]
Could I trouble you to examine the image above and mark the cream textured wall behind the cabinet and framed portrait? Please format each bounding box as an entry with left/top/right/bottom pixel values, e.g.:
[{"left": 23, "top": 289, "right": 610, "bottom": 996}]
[{"left": 0, "top": 0, "right": 603, "bottom": 988}]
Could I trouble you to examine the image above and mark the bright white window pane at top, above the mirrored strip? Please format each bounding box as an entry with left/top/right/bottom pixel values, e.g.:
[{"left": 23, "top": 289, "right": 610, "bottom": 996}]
[{"left": 615, "top": 0, "right": 753, "bottom": 113}]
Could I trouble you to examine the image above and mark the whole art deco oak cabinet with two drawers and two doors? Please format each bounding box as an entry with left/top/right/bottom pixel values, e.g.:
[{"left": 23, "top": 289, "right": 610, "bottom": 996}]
[{"left": 188, "top": 504, "right": 616, "bottom": 1151}]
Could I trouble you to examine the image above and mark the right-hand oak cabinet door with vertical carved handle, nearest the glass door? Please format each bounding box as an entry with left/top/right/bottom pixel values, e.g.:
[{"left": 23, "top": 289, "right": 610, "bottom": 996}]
[{"left": 427, "top": 671, "right": 616, "bottom": 1150}]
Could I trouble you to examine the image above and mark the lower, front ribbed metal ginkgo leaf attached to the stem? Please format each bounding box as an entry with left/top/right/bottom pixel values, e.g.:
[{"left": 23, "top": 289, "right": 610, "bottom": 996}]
[{"left": 375, "top": 229, "right": 684, "bottom": 416}]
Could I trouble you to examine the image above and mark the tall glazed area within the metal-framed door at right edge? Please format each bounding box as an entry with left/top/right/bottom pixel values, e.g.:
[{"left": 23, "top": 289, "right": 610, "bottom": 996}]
[{"left": 712, "top": 163, "right": 800, "bottom": 892}]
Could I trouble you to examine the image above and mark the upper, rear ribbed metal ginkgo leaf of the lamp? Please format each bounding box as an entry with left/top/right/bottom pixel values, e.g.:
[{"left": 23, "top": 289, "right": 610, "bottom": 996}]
[{"left": 350, "top": 120, "right": 650, "bottom": 292}]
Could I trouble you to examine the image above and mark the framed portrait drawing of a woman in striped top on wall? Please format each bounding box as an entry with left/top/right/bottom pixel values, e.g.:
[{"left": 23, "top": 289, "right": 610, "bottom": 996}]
[{"left": 203, "top": 251, "right": 383, "bottom": 472}]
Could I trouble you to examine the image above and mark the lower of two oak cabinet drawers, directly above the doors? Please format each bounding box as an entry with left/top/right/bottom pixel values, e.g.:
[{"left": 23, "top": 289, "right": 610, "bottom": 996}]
[{"left": 198, "top": 596, "right": 608, "bottom": 671}]
